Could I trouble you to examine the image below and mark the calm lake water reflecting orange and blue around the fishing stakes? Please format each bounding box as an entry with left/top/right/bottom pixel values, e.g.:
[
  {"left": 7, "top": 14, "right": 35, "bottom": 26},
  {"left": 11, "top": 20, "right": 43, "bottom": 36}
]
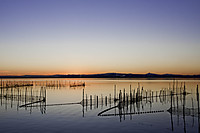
[{"left": 0, "top": 79, "right": 200, "bottom": 133}]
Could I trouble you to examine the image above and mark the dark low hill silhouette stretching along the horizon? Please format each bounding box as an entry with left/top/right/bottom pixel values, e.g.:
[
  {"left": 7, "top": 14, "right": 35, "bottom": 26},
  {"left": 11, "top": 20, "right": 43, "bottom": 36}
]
[{"left": 0, "top": 73, "right": 200, "bottom": 78}]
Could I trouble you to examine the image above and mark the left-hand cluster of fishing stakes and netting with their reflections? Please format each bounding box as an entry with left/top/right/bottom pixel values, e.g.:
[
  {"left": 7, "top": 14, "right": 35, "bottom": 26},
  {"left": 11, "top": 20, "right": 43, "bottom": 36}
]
[{"left": 0, "top": 85, "right": 46, "bottom": 114}]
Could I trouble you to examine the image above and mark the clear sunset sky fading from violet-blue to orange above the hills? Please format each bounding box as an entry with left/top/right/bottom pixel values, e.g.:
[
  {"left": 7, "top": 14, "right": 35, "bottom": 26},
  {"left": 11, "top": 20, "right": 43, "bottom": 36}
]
[{"left": 0, "top": 0, "right": 200, "bottom": 75}]
